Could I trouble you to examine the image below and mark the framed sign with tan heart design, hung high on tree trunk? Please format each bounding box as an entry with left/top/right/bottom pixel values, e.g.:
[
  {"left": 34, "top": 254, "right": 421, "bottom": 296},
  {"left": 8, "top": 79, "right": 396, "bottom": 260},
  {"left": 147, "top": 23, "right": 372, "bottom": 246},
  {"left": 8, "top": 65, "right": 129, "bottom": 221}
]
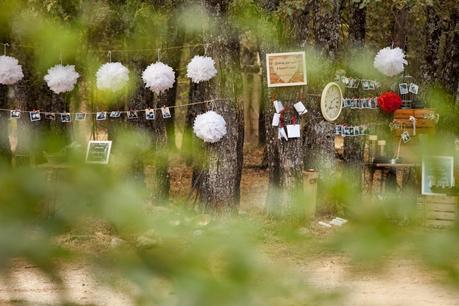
[{"left": 266, "top": 51, "right": 307, "bottom": 87}]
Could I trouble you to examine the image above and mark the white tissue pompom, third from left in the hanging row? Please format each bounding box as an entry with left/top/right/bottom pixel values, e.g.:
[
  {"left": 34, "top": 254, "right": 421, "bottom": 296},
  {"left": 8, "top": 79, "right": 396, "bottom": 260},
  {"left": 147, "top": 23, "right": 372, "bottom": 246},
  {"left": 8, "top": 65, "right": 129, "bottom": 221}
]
[{"left": 96, "top": 63, "right": 129, "bottom": 91}]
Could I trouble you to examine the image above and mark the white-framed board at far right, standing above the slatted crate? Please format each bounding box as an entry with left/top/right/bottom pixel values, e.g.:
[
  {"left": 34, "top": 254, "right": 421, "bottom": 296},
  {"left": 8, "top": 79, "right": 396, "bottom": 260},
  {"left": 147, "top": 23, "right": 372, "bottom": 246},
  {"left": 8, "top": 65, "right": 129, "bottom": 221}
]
[{"left": 422, "top": 156, "right": 454, "bottom": 195}]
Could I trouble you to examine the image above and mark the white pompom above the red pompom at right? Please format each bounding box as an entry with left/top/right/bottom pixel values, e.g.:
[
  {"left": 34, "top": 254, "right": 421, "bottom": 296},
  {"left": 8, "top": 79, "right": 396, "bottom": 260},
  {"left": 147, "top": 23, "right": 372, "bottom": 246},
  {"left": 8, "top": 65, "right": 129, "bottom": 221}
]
[{"left": 373, "top": 47, "right": 408, "bottom": 77}]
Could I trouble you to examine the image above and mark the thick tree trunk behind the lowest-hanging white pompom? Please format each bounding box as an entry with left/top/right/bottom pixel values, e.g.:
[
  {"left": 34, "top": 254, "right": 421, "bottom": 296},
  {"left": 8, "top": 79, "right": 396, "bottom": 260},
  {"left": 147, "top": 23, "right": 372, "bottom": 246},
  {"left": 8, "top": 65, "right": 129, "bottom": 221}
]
[{"left": 190, "top": 1, "right": 244, "bottom": 213}]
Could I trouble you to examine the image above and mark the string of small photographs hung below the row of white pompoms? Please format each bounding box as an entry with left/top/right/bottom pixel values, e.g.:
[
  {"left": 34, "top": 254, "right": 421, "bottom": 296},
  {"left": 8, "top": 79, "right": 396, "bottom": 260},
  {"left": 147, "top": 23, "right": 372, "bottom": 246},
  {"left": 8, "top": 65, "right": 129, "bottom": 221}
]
[{"left": 0, "top": 99, "right": 223, "bottom": 123}]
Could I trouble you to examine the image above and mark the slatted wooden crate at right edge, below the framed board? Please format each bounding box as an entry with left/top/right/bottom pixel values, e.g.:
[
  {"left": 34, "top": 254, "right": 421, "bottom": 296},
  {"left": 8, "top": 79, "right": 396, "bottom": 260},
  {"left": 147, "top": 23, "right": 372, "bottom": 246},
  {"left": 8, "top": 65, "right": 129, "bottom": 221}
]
[{"left": 418, "top": 195, "right": 458, "bottom": 227}]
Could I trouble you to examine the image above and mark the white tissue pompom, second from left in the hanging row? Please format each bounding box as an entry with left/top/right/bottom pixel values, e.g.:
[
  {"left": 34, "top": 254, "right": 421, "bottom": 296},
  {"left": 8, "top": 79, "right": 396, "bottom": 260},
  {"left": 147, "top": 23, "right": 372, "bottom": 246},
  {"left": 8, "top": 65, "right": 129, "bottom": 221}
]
[{"left": 44, "top": 65, "right": 80, "bottom": 94}]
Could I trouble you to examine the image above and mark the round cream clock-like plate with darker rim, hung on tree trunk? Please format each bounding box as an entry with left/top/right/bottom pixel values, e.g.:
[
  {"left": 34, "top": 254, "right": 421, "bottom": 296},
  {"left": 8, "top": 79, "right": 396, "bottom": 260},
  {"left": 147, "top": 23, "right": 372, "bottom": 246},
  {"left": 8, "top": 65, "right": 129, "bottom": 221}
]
[{"left": 320, "top": 82, "right": 343, "bottom": 121}]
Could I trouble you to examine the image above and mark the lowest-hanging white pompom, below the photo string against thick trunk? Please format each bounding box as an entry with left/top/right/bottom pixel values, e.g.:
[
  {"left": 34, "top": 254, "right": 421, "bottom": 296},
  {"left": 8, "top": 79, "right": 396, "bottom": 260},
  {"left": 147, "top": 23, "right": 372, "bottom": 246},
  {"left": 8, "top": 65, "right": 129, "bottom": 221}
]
[{"left": 193, "top": 111, "right": 226, "bottom": 143}]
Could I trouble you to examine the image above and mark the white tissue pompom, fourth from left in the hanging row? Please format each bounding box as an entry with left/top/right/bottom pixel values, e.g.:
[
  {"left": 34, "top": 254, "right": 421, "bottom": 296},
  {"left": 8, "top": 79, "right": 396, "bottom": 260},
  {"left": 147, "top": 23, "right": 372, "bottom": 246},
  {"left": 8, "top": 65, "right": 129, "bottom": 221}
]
[{"left": 142, "top": 62, "right": 175, "bottom": 94}]
